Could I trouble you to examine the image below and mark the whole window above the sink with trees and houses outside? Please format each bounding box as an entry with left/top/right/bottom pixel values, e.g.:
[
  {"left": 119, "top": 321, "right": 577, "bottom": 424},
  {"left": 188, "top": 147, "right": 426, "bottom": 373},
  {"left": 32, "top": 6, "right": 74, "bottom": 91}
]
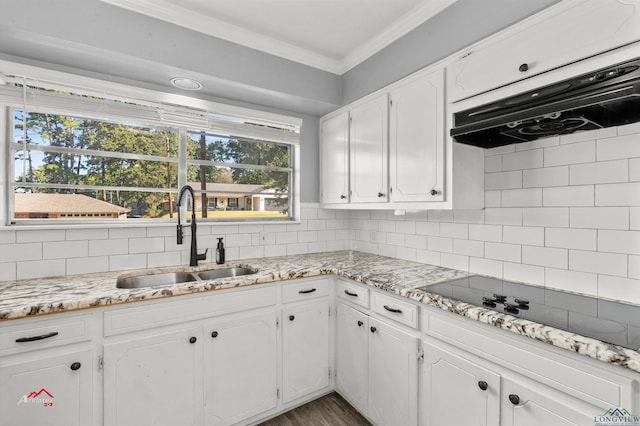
[{"left": 0, "top": 66, "right": 299, "bottom": 224}]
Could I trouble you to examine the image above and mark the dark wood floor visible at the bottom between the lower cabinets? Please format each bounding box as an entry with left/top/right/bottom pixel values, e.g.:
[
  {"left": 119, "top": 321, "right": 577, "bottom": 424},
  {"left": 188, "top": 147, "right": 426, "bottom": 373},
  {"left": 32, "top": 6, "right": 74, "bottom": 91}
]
[{"left": 258, "top": 392, "right": 371, "bottom": 426}]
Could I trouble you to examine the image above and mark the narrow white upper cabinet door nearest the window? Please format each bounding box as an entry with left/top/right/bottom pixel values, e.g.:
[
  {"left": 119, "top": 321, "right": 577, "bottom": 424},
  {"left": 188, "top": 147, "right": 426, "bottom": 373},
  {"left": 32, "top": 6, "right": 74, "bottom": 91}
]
[{"left": 320, "top": 112, "right": 349, "bottom": 204}]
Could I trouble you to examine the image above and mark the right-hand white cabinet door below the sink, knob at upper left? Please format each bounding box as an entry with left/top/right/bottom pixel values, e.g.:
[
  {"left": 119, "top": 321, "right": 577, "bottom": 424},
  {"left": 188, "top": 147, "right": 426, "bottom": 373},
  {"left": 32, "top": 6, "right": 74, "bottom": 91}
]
[{"left": 204, "top": 311, "right": 278, "bottom": 425}]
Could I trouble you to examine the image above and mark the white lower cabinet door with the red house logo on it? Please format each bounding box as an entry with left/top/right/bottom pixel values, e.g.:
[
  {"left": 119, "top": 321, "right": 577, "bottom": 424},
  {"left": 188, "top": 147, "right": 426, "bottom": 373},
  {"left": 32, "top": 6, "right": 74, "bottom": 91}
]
[{"left": 0, "top": 350, "right": 93, "bottom": 426}]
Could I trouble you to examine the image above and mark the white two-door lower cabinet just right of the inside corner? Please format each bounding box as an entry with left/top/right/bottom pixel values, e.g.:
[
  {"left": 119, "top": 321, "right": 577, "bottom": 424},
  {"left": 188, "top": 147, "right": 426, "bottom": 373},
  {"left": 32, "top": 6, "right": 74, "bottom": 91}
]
[{"left": 336, "top": 303, "right": 418, "bottom": 426}]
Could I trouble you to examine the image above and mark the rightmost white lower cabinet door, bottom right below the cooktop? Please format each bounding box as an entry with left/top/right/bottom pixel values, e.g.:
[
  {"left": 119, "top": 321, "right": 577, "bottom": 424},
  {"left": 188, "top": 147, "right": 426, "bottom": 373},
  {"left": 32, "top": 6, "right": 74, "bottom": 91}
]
[{"left": 500, "top": 378, "right": 612, "bottom": 426}]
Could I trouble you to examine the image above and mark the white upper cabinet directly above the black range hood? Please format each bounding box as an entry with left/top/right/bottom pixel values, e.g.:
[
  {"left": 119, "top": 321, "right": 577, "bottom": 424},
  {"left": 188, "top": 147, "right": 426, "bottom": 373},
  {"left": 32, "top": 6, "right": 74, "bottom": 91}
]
[{"left": 448, "top": 0, "right": 640, "bottom": 102}]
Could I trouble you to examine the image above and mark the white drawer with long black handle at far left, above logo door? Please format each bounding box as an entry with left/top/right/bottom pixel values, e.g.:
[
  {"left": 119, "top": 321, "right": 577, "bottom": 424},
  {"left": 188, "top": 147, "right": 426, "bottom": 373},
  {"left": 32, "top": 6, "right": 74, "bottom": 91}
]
[{"left": 0, "top": 314, "right": 91, "bottom": 356}]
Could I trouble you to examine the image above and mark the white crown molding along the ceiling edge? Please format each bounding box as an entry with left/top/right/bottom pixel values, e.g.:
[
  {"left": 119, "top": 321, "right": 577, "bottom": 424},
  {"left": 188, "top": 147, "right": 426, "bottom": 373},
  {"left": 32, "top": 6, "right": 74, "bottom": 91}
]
[{"left": 101, "top": 0, "right": 457, "bottom": 75}]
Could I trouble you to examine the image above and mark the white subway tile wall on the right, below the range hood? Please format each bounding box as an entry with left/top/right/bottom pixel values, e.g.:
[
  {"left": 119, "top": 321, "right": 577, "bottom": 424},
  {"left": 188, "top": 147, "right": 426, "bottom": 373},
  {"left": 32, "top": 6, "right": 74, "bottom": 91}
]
[{"left": 349, "top": 123, "right": 640, "bottom": 303}]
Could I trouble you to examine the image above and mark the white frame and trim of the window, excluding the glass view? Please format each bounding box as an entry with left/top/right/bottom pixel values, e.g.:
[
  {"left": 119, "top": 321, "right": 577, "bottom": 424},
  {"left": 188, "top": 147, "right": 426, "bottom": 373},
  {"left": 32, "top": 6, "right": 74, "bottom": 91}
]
[{"left": 0, "top": 60, "right": 302, "bottom": 229}]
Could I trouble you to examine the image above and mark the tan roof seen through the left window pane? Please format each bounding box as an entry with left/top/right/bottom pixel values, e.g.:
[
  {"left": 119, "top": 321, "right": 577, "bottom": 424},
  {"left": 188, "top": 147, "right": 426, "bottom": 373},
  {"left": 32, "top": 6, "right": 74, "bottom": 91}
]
[{"left": 14, "top": 192, "right": 129, "bottom": 214}]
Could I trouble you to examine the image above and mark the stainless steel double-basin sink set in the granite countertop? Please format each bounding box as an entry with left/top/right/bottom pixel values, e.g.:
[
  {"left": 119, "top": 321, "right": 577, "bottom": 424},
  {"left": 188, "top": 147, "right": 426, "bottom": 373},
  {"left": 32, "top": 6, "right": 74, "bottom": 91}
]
[{"left": 116, "top": 267, "right": 258, "bottom": 288}]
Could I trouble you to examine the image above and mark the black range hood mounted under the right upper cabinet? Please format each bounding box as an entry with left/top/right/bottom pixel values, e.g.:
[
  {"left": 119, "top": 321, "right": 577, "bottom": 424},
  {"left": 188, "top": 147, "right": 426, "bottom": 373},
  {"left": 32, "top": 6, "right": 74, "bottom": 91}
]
[{"left": 451, "top": 58, "right": 640, "bottom": 148}]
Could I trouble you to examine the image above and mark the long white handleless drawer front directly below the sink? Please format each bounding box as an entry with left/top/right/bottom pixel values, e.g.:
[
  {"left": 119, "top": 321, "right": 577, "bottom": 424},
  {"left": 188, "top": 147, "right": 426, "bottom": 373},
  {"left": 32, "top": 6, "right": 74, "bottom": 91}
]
[{"left": 104, "top": 284, "right": 277, "bottom": 336}]
